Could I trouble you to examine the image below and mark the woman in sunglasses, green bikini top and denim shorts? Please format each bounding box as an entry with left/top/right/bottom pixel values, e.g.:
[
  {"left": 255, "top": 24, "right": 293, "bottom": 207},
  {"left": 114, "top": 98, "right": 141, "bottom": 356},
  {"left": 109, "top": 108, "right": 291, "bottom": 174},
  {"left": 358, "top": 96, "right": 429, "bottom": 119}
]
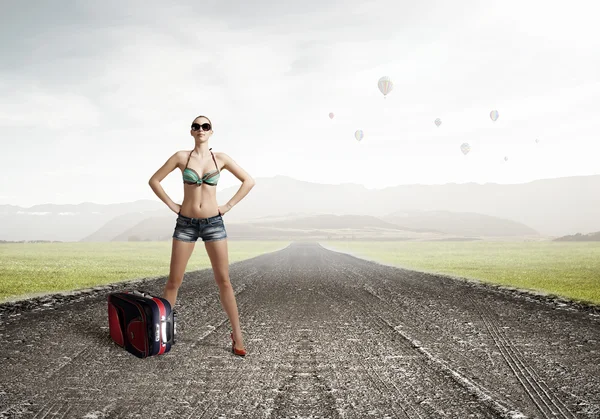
[{"left": 148, "top": 116, "right": 255, "bottom": 356}]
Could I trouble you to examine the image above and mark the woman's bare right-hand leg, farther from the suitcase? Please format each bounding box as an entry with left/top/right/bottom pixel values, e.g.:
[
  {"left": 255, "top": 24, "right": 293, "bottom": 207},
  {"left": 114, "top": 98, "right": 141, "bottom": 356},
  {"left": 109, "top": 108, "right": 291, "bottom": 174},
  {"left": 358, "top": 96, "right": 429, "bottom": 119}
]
[{"left": 204, "top": 238, "right": 244, "bottom": 349}]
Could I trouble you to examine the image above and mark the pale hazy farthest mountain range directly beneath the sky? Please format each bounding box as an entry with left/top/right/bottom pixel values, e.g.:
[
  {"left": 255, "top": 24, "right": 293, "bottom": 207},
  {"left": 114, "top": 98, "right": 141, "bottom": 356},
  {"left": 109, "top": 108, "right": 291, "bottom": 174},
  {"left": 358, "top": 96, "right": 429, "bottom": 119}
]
[{"left": 0, "top": 175, "right": 600, "bottom": 241}]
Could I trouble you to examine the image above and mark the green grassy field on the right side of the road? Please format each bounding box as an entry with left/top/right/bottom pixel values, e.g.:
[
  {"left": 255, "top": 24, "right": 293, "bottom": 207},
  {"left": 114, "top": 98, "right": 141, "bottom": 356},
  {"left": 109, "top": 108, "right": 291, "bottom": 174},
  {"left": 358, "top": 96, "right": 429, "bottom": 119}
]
[{"left": 321, "top": 241, "right": 600, "bottom": 304}]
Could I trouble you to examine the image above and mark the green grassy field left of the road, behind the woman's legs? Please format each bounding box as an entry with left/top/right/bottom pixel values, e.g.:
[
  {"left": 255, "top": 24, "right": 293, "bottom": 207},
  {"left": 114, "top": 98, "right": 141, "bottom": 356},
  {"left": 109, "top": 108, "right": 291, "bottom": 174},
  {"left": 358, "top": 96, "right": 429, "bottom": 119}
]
[{"left": 0, "top": 240, "right": 290, "bottom": 302}]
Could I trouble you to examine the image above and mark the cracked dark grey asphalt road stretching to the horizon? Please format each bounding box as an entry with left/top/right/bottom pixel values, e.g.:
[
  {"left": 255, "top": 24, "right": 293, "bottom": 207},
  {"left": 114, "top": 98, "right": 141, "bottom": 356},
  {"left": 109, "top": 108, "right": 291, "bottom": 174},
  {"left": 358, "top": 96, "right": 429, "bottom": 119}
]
[{"left": 0, "top": 242, "right": 600, "bottom": 419}]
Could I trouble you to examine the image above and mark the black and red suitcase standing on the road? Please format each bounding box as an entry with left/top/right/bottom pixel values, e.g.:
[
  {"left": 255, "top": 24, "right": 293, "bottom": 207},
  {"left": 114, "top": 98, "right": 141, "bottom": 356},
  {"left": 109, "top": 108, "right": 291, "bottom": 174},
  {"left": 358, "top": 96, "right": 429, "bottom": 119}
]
[{"left": 108, "top": 291, "right": 177, "bottom": 358}]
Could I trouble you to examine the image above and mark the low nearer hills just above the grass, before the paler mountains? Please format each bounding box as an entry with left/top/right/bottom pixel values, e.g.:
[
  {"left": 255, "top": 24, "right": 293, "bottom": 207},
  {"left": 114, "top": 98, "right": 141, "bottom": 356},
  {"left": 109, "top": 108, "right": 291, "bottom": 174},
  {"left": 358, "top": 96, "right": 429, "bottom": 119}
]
[{"left": 95, "top": 212, "right": 537, "bottom": 241}]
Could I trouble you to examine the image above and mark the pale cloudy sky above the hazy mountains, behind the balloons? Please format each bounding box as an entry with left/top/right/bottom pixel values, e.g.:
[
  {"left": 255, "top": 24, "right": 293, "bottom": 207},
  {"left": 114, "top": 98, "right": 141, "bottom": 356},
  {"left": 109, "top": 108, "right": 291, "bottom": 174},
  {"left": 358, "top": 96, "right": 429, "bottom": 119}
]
[{"left": 0, "top": 0, "right": 600, "bottom": 207}]
